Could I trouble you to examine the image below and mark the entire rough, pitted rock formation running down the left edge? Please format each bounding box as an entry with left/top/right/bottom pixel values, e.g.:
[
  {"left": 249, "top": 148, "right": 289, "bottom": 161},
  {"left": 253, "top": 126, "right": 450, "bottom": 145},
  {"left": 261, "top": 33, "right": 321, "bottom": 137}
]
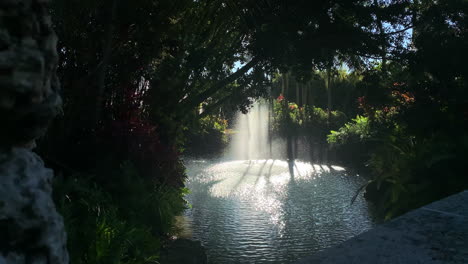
[{"left": 0, "top": 0, "right": 68, "bottom": 264}]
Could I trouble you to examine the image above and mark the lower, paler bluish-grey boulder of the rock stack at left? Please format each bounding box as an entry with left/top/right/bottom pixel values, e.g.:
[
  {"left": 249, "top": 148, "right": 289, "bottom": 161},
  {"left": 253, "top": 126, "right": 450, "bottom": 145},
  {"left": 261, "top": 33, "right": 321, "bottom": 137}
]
[{"left": 0, "top": 148, "right": 69, "bottom": 264}]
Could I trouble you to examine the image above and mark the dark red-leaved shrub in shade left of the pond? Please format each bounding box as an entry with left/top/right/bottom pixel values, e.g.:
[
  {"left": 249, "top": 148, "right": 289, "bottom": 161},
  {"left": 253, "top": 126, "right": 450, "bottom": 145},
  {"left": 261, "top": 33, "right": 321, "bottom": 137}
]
[{"left": 100, "top": 83, "right": 185, "bottom": 187}]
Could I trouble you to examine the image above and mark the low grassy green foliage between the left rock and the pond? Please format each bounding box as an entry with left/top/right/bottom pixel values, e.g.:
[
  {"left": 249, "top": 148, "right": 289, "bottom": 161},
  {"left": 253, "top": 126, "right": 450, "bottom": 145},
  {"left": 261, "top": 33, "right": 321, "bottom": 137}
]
[{"left": 54, "top": 163, "right": 186, "bottom": 264}]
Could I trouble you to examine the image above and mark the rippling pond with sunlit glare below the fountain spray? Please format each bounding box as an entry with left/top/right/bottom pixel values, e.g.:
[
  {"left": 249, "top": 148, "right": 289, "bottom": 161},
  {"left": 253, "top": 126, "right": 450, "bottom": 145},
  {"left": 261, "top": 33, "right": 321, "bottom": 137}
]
[{"left": 181, "top": 159, "right": 373, "bottom": 264}]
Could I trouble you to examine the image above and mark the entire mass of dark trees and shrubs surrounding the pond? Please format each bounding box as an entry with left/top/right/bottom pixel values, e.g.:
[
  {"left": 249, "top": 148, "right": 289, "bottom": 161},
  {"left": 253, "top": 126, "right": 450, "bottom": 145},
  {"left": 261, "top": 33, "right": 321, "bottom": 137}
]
[{"left": 30, "top": 0, "right": 468, "bottom": 263}]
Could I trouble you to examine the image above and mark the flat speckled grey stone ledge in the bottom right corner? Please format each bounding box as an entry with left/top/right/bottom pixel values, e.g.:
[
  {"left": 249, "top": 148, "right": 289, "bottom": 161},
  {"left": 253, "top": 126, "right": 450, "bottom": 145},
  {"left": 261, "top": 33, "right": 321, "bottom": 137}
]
[{"left": 297, "top": 191, "right": 468, "bottom": 264}]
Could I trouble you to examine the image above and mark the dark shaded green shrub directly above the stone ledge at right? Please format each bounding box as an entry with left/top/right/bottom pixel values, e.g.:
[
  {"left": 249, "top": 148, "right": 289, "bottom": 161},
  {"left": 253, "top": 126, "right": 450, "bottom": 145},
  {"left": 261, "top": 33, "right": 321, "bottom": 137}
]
[{"left": 369, "top": 130, "right": 468, "bottom": 219}]
